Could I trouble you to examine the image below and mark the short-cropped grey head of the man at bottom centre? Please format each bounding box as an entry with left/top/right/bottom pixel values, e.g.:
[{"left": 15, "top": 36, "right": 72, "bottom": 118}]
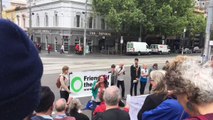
[{"left": 104, "top": 86, "right": 121, "bottom": 106}]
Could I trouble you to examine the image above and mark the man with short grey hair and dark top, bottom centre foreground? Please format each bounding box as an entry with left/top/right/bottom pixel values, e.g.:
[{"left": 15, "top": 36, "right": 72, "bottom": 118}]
[{"left": 93, "top": 86, "right": 130, "bottom": 120}]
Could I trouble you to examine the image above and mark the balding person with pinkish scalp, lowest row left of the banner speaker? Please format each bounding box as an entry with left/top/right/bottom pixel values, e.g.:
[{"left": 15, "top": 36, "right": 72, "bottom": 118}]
[{"left": 54, "top": 98, "right": 75, "bottom": 120}]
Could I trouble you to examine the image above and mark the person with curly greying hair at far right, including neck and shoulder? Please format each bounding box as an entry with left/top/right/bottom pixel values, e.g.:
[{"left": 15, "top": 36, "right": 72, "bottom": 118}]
[{"left": 166, "top": 56, "right": 213, "bottom": 120}]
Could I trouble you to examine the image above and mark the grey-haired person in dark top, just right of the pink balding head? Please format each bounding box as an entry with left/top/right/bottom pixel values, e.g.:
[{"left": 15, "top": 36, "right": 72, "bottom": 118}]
[{"left": 68, "top": 99, "right": 89, "bottom": 120}]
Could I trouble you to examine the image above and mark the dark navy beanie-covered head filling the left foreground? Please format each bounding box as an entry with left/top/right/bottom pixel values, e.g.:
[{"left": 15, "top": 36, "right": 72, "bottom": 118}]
[{"left": 0, "top": 19, "right": 43, "bottom": 120}]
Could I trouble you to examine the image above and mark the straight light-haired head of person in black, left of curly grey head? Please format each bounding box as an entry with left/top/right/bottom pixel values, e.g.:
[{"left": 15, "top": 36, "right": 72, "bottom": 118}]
[{"left": 150, "top": 70, "right": 167, "bottom": 94}]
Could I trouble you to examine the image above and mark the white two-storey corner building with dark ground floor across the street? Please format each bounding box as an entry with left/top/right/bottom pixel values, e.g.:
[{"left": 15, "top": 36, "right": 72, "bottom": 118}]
[{"left": 31, "top": 0, "right": 115, "bottom": 53}]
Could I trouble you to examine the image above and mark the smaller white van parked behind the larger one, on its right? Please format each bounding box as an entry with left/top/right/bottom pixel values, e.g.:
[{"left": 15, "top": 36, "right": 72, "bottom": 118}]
[{"left": 150, "top": 44, "right": 170, "bottom": 54}]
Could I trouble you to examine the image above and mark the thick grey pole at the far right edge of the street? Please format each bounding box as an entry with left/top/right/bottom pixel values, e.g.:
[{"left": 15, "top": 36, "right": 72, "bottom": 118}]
[{"left": 202, "top": 0, "right": 213, "bottom": 63}]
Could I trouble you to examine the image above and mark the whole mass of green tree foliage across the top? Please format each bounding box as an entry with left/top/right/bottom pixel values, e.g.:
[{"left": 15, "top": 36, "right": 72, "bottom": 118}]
[{"left": 93, "top": 0, "right": 206, "bottom": 36}]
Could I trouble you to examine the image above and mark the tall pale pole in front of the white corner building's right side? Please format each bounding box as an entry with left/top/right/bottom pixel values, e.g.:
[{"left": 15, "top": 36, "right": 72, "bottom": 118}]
[{"left": 83, "top": 0, "right": 88, "bottom": 56}]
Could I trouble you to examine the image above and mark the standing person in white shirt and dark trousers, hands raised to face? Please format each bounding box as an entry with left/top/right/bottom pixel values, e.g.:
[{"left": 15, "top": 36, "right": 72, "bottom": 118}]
[{"left": 116, "top": 63, "right": 125, "bottom": 99}]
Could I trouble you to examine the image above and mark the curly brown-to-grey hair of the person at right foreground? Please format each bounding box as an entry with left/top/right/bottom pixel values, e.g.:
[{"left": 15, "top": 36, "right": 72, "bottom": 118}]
[{"left": 166, "top": 56, "right": 213, "bottom": 105}]
